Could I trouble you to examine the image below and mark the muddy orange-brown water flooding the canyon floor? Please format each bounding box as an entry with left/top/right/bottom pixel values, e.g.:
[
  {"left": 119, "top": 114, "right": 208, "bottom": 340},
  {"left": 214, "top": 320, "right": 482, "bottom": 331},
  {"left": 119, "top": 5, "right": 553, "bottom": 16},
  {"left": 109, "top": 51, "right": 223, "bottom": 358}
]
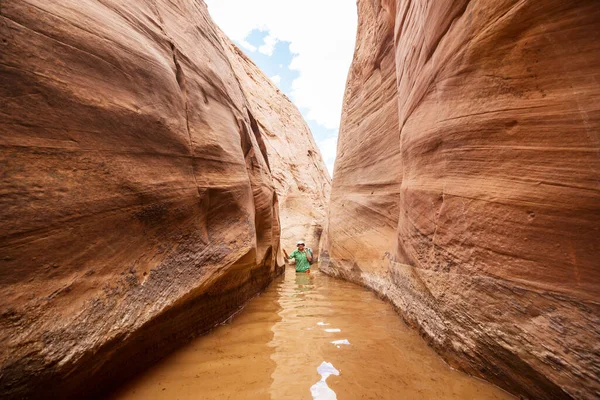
[{"left": 113, "top": 269, "right": 512, "bottom": 400}]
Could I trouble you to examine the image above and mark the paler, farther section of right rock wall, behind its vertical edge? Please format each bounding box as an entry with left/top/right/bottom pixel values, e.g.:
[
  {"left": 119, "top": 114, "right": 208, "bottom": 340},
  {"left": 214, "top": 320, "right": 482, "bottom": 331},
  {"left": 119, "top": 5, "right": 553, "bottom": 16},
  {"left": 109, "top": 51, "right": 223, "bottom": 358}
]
[{"left": 320, "top": 2, "right": 402, "bottom": 290}]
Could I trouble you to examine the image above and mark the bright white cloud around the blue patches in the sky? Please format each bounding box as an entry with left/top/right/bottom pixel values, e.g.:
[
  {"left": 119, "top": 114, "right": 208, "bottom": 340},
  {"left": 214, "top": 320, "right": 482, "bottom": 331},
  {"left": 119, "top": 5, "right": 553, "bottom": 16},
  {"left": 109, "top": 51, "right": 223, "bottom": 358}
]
[{"left": 206, "top": 0, "right": 356, "bottom": 129}]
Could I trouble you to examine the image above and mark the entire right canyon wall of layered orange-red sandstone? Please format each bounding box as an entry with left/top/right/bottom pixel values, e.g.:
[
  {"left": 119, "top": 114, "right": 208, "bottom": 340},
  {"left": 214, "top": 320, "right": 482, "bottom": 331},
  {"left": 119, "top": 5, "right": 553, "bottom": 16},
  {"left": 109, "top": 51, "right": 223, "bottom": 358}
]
[{"left": 321, "top": 0, "right": 600, "bottom": 398}]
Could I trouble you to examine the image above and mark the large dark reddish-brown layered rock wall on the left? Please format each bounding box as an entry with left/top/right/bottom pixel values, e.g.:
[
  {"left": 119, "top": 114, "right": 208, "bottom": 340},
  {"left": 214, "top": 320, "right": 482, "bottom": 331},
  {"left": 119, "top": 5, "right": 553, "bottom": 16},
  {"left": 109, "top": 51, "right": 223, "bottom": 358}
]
[{"left": 0, "top": 0, "right": 329, "bottom": 398}]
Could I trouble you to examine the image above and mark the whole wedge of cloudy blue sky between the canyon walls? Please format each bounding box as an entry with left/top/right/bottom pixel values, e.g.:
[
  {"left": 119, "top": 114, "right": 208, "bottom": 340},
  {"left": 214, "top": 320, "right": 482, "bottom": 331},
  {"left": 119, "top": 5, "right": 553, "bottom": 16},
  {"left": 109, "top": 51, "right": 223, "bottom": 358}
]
[{"left": 205, "top": 0, "right": 357, "bottom": 176}]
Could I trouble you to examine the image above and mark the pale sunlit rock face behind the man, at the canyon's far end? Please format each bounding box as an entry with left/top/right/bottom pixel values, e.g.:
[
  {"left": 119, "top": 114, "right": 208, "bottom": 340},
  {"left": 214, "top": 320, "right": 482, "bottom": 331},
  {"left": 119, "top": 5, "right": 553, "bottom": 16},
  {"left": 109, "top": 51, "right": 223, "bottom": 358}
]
[{"left": 221, "top": 40, "right": 331, "bottom": 252}]
